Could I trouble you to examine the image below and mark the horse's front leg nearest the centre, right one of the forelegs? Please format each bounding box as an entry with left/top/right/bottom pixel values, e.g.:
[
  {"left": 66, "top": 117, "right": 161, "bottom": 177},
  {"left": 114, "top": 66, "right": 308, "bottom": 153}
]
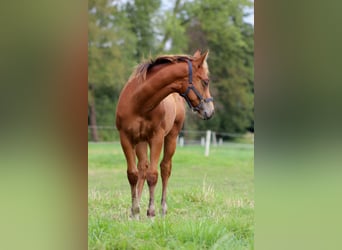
[{"left": 146, "top": 133, "right": 164, "bottom": 217}]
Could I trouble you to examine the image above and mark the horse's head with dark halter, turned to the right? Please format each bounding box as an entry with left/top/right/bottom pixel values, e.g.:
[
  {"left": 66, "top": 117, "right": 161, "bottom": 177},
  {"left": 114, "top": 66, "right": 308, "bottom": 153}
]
[{"left": 180, "top": 50, "right": 214, "bottom": 120}]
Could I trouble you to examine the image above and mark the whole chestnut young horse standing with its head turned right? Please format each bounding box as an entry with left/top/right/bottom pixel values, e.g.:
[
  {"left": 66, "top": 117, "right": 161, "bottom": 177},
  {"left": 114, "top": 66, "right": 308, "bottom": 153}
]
[{"left": 116, "top": 51, "right": 214, "bottom": 217}]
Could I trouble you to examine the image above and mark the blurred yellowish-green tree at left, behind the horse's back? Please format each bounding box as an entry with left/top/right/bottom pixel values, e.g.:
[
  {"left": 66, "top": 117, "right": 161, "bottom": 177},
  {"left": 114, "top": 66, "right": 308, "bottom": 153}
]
[{"left": 88, "top": 0, "right": 136, "bottom": 141}]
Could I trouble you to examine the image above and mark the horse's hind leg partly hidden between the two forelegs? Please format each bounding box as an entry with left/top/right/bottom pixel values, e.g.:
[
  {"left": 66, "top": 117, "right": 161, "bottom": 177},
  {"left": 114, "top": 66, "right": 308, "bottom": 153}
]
[{"left": 135, "top": 142, "right": 148, "bottom": 203}]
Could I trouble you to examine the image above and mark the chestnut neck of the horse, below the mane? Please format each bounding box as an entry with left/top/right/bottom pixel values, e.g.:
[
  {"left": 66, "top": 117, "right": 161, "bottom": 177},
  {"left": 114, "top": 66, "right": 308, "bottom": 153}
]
[{"left": 134, "top": 63, "right": 188, "bottom": 112}]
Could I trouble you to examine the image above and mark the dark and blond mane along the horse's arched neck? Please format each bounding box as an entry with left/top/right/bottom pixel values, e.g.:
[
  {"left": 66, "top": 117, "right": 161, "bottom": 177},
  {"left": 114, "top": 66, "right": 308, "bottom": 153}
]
[{"left": 128, "top": 55, "right": 193, "bottom": 81}]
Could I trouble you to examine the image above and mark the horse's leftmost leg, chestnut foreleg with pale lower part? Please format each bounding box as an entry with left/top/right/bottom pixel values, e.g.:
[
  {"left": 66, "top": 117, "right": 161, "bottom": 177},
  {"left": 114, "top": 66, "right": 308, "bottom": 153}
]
[{"left": 120, "top": 133, "right": 140, "bottom": 217}]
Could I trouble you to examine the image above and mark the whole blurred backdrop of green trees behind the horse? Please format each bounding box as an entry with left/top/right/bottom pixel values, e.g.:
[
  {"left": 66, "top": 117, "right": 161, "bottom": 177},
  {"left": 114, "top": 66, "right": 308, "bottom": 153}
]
[{"left": 88, "top": 0, "right": 254, "bottom": 140}]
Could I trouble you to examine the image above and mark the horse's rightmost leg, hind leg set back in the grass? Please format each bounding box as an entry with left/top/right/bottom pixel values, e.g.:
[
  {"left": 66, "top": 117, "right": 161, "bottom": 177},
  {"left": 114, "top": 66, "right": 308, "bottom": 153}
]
[{"left": 160, "top": 134, "right": 177, "bottom": 216}]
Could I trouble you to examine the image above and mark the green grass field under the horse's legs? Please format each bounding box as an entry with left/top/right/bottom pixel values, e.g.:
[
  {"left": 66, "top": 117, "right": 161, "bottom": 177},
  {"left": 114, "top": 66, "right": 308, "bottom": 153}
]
[{"left": 88, "top": 143, "right": 254, "bottom": 250}]
